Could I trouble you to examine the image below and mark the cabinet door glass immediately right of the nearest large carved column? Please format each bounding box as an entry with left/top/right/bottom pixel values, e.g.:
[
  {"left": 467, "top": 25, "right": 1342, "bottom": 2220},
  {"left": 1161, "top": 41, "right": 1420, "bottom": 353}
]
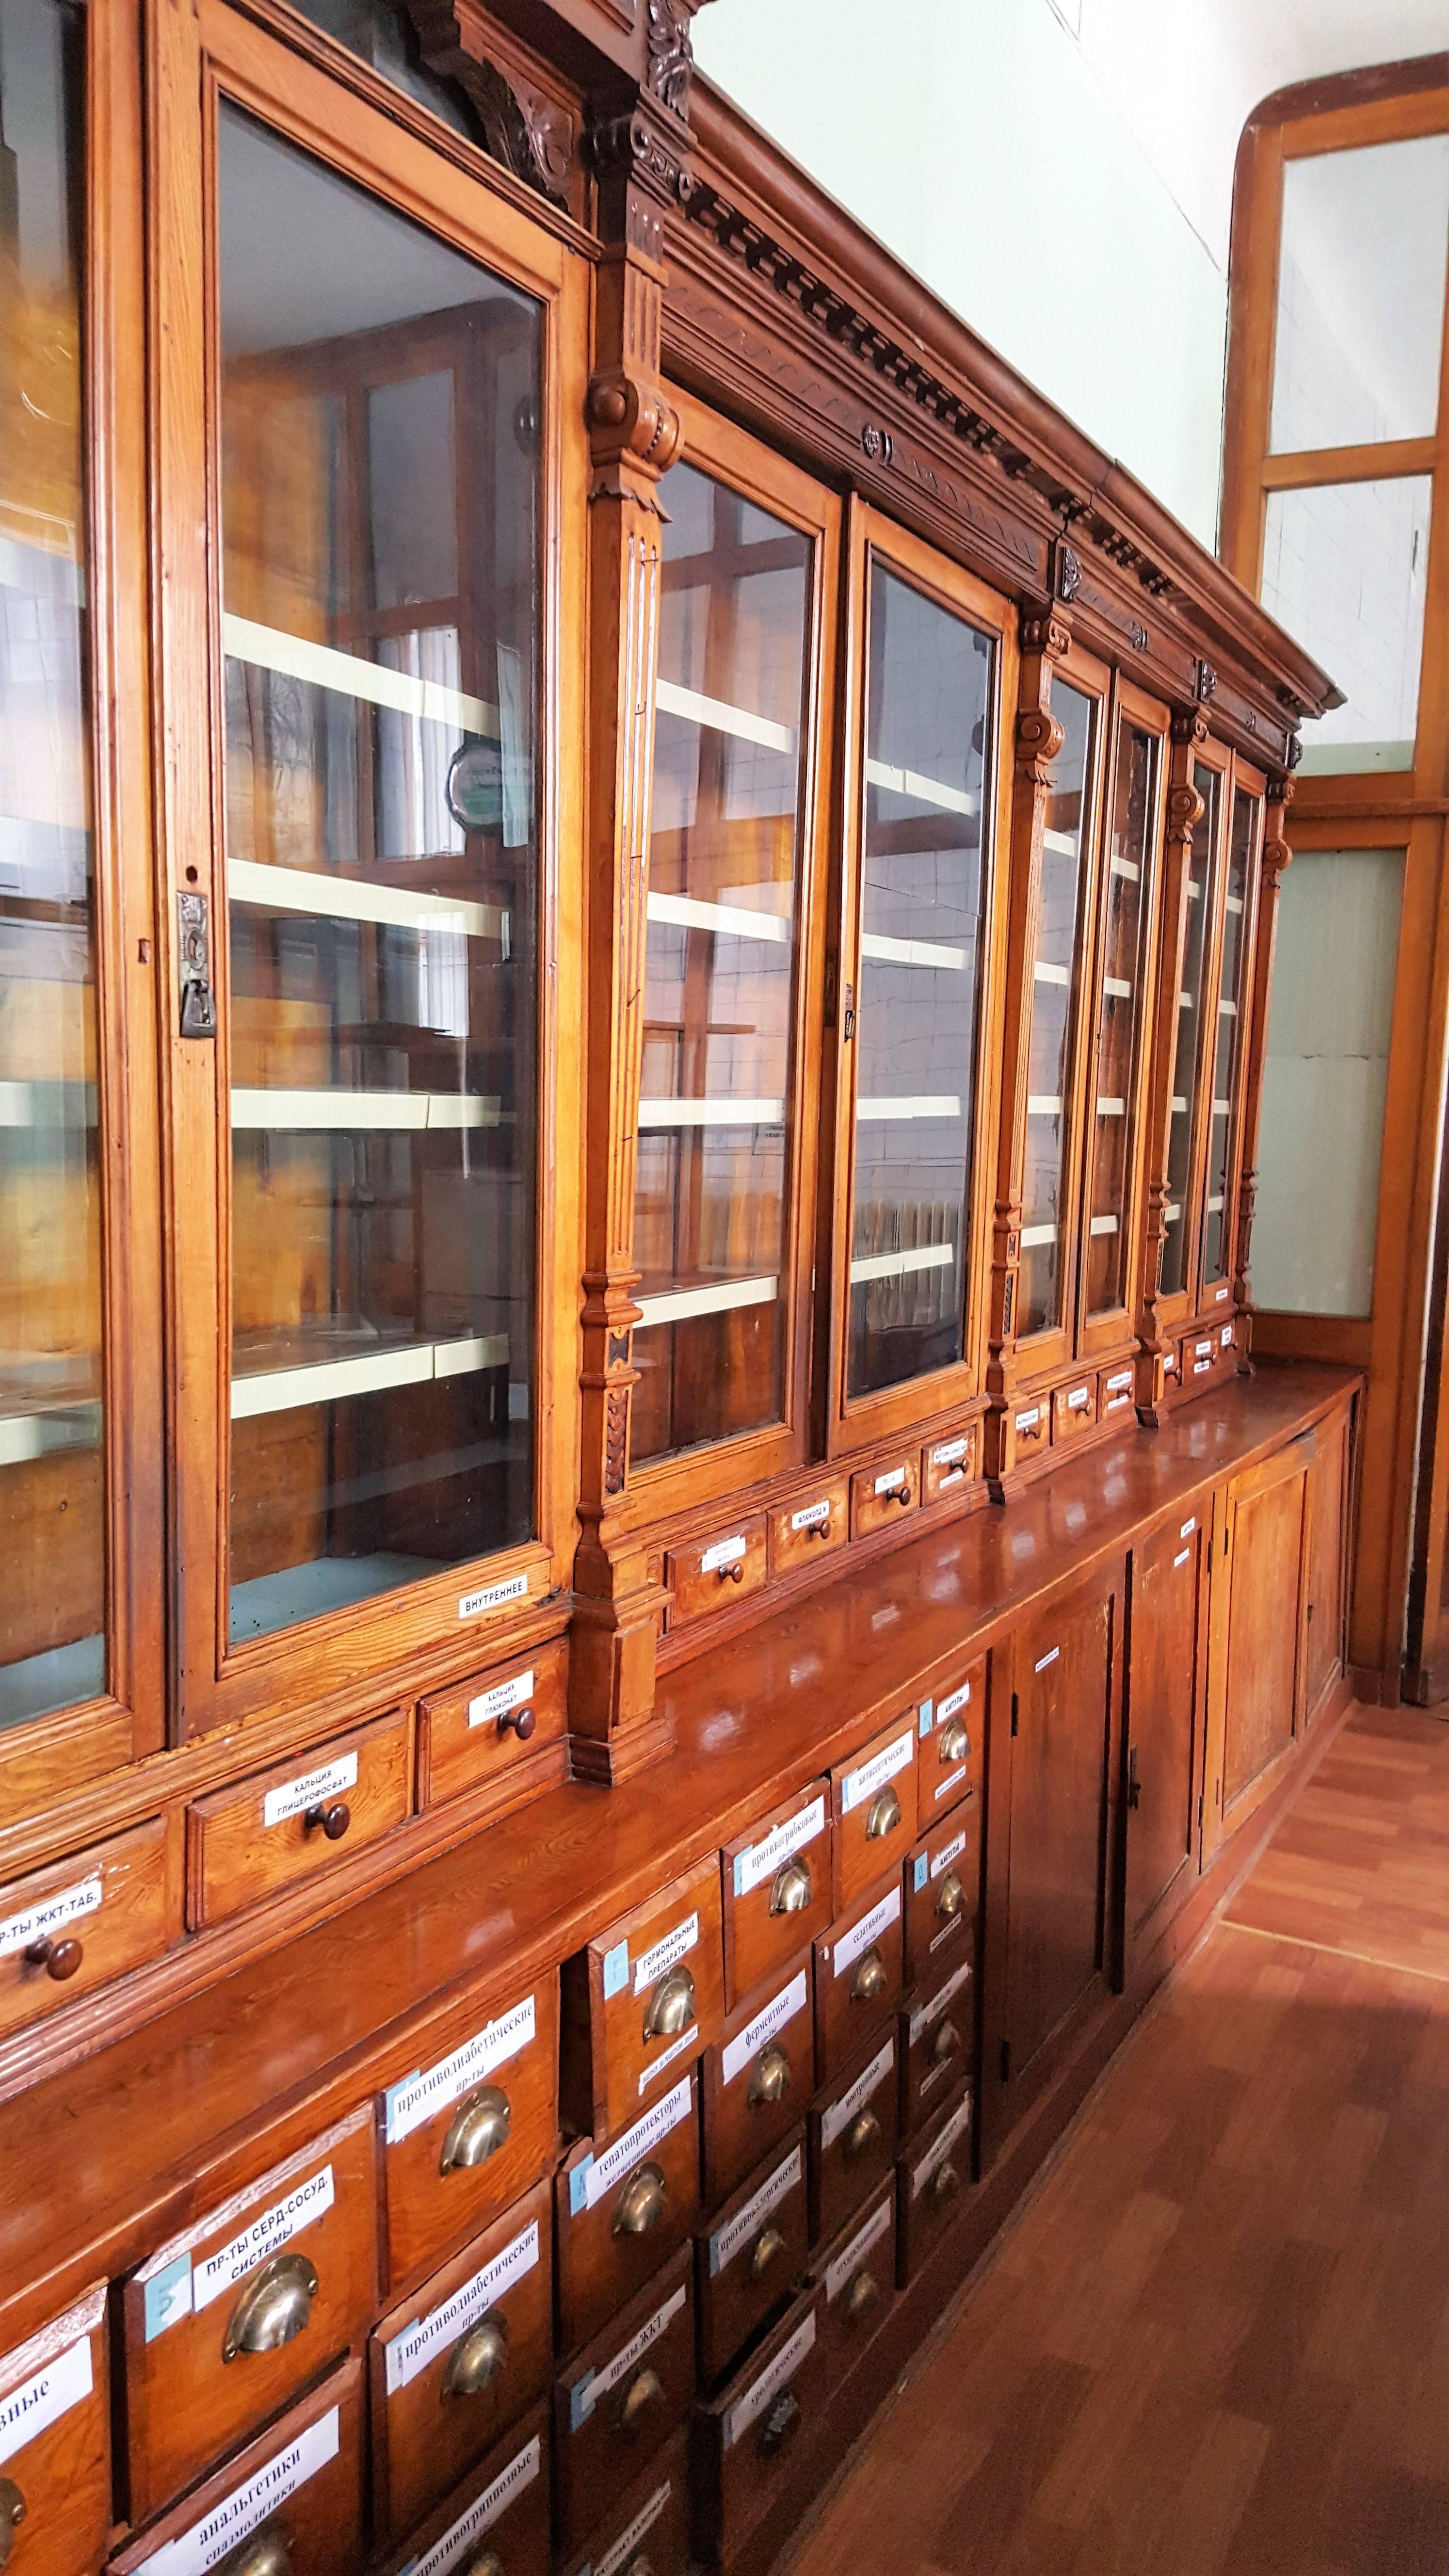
[{"left": 632, "top": 464, "right": 812, "bottom": 1461}]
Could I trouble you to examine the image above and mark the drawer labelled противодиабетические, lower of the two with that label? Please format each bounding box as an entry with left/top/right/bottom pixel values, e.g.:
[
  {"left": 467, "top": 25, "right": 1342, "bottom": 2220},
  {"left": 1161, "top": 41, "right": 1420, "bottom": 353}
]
[{"left": 369, "top": 2182, "right": 554, "bottom": 2540}]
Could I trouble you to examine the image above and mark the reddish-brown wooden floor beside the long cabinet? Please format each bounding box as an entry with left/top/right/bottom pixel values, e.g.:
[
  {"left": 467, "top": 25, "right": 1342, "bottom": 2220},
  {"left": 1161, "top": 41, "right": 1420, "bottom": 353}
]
[{"left": 791, "top": 1710, "right": 1449, "bottom": 2576}]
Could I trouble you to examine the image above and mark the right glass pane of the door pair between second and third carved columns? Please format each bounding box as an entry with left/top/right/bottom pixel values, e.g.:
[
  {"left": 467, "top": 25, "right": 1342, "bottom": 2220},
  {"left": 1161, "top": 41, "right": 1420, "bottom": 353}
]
[{"left": 1085, "top": 719, "right": 1163, "bottom": 1316}]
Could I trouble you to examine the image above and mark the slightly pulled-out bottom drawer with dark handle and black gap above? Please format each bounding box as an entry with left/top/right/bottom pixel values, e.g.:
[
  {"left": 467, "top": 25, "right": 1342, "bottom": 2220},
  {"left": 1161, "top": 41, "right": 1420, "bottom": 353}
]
[{"left": 693, "top": 2290, "right": 825, "bottom": 2568}]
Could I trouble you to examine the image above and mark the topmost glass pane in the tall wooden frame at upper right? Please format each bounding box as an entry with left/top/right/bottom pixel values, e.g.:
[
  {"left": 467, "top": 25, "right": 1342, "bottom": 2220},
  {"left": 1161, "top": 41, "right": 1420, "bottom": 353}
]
[{"left": 1271, "top": 134, "right": 1449, "bottom": 456}]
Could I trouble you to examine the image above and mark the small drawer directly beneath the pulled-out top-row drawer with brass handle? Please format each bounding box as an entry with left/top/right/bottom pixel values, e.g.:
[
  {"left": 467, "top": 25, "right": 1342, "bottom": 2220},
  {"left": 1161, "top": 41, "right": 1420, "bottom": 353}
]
[{"left": 557, "top": 2074, "right": 699, "bottom": 2352}]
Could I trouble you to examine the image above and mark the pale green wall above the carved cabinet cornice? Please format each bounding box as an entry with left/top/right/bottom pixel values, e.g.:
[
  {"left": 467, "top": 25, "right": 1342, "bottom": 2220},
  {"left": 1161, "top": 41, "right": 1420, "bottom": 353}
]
[{"left": 693, "top": 0, "right": 1227, "bottom": 546}]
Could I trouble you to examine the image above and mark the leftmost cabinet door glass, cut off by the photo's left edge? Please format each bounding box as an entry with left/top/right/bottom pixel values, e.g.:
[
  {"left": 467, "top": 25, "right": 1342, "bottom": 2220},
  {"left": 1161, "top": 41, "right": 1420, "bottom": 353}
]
[{"left": 0, "top": 0, "right": 106, "bottom": 1728}]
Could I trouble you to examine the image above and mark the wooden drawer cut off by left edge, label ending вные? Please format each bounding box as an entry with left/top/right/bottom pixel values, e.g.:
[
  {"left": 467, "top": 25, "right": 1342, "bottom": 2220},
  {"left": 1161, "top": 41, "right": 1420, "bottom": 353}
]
[{"left": 0, "top": 2282, "right": 111, "bottom": 2576}]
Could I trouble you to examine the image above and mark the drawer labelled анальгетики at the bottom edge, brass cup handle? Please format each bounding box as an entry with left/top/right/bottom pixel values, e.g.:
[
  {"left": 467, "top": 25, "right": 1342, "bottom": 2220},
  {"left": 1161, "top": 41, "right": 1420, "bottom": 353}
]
[{"left": 112, "top": 2362, "right": 364, "bottom": 2576}]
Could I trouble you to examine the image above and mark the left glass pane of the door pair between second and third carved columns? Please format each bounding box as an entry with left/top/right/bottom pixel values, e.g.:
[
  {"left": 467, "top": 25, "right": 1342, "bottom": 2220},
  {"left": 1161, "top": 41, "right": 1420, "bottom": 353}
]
[{"left": 1016, "top": 680, "right": 1096, "bottom": 1339}]
